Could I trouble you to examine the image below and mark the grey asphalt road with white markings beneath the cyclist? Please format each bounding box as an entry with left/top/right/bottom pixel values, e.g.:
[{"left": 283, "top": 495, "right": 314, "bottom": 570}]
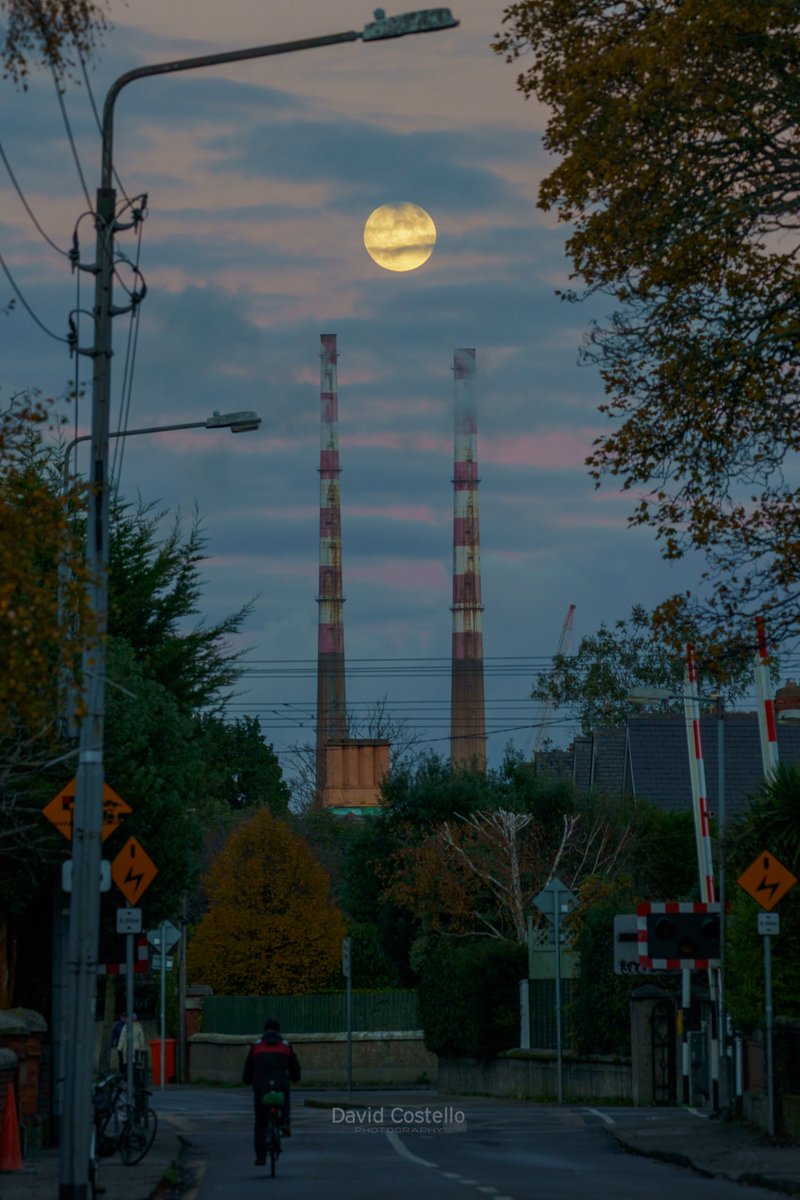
[{"left": 154, "top": 1088, "right": 775, "bottom": 1200}]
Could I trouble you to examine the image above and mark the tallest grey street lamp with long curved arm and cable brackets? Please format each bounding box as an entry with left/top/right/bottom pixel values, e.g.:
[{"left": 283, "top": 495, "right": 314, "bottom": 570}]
[{"left": 59, "top": 8, "right": 458, "bottom": 1200}]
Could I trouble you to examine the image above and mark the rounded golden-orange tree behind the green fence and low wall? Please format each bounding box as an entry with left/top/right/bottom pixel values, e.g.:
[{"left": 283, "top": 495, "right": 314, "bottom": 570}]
[{"left": 188, "top": 809, "right": 345, "bottom": 996}]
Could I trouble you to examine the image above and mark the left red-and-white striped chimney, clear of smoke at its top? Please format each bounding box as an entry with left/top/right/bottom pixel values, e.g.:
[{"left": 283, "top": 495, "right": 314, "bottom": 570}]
[{"left": 317, "top": 334, "right": 347, "bottom": 804}]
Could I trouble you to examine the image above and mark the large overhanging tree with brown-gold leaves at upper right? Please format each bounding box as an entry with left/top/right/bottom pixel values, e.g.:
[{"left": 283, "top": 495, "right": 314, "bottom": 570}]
[{"left": 494, "top": 0, "right": 800, "bottom": 653}]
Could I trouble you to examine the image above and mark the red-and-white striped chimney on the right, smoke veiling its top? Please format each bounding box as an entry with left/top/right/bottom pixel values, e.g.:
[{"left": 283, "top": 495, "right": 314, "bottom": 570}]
[{"left": 450, "top": 349, "right": 486, "bottom": 770}]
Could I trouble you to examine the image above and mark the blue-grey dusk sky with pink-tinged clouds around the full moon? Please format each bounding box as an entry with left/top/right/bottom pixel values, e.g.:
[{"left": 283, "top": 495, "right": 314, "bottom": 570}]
[{"left": 0, "top": 0, "right": 724, "bottom": 777}]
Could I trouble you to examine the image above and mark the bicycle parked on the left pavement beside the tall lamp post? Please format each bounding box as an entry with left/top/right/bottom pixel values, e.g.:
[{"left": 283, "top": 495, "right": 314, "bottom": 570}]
[{"left": 89, "top": 1074, "right": 158, "bottom": 1200}]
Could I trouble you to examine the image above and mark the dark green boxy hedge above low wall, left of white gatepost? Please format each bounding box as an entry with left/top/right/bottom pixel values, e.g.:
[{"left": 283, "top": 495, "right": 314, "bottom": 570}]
[{"left": 419, "top": 938, "right": 528, "bottom": 1060}]
